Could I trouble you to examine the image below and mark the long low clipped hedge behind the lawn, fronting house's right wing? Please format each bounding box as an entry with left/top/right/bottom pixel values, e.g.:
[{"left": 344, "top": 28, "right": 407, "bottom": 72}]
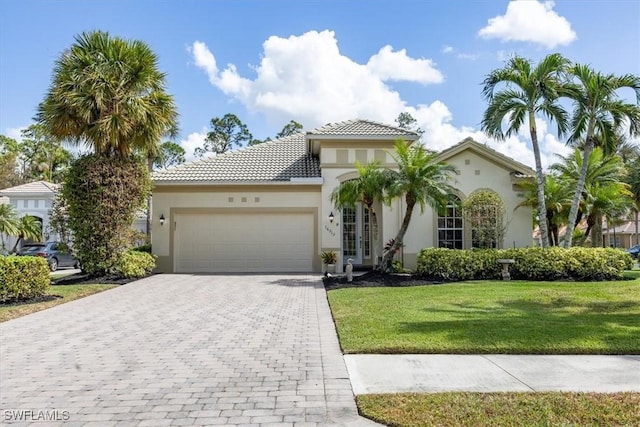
[{"left": 417, "top": 247, "right": 633, "bottom": 281}]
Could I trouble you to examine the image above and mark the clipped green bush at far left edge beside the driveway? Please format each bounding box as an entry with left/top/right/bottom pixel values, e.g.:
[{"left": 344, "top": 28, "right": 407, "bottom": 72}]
[{"left": 0, "top": 256, "right": 51, "bottom": 302}]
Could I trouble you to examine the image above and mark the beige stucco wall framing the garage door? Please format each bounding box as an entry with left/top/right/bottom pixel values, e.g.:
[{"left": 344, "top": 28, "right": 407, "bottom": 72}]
[{"left": 151, "top": 185, "right": 328, "bottom": 272}]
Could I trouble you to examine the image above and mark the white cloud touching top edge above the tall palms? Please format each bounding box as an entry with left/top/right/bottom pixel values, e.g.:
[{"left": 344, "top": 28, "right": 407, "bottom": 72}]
[{"left": 478, "top": 0, "right": 577, "bottom": 49}]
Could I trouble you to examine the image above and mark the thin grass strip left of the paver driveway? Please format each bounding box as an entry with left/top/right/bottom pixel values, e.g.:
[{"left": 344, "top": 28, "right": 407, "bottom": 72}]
[{"left": 0, "top": 285, "right": 117, "bottom": 322}]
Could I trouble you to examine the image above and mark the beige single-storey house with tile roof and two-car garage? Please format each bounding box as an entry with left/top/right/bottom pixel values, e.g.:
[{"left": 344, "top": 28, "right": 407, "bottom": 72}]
[{"left": 152, "top": 120, "right": 534, "bottom": 273}]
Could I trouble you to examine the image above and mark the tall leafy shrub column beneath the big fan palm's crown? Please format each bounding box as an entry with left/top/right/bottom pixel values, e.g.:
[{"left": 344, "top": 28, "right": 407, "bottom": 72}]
[{"left": 62, "top": 155, "right": 151, "bottom": 276}]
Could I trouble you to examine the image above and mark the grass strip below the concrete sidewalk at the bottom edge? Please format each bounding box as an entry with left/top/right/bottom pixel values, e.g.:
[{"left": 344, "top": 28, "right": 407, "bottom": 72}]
[{"left": 356, "top": 393, "right": 640, "bottom": 427}]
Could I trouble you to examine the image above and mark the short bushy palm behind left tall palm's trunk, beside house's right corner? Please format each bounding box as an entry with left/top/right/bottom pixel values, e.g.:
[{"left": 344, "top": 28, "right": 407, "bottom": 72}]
[{"left": 516, "top": 175, "right": 573, "bottom": 246}]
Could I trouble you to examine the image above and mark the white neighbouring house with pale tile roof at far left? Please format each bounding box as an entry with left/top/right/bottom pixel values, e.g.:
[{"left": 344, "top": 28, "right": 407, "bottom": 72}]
[{"left": 0, "top": 181, "right": 59, "bottom": 250}]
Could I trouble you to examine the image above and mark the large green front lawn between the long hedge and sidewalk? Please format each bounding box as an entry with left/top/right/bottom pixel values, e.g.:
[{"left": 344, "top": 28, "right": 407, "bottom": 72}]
[{"left": 328, "top": 279, "right": 640, "bottom": 354}]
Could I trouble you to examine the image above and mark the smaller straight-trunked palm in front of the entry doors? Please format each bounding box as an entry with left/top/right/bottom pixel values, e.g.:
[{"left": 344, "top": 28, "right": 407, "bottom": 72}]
[{"left": 331, "top": 162, "right": 391, "bottom": 267}]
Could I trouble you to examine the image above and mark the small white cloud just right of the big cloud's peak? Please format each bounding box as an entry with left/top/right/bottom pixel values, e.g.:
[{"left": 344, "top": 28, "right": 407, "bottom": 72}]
[{"left": 367, "top": 45, "right": 444, "bottom": 84}]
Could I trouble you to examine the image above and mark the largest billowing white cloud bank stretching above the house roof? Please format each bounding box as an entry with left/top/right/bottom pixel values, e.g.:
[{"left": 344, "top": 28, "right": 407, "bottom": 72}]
[{"left": 189, "top": 31, "right": 562, "bottom": 171}]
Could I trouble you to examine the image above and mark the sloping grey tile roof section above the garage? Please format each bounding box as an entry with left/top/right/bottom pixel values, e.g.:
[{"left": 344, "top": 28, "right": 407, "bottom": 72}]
[{"left": 152, "top": 132, "right": 321, "bottom": 183}]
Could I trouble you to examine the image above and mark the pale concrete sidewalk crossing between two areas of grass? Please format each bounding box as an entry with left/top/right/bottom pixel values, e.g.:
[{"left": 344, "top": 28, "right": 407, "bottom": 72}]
[{"left": 344, "top": 354, "right": 640, "bottom": 395}]
